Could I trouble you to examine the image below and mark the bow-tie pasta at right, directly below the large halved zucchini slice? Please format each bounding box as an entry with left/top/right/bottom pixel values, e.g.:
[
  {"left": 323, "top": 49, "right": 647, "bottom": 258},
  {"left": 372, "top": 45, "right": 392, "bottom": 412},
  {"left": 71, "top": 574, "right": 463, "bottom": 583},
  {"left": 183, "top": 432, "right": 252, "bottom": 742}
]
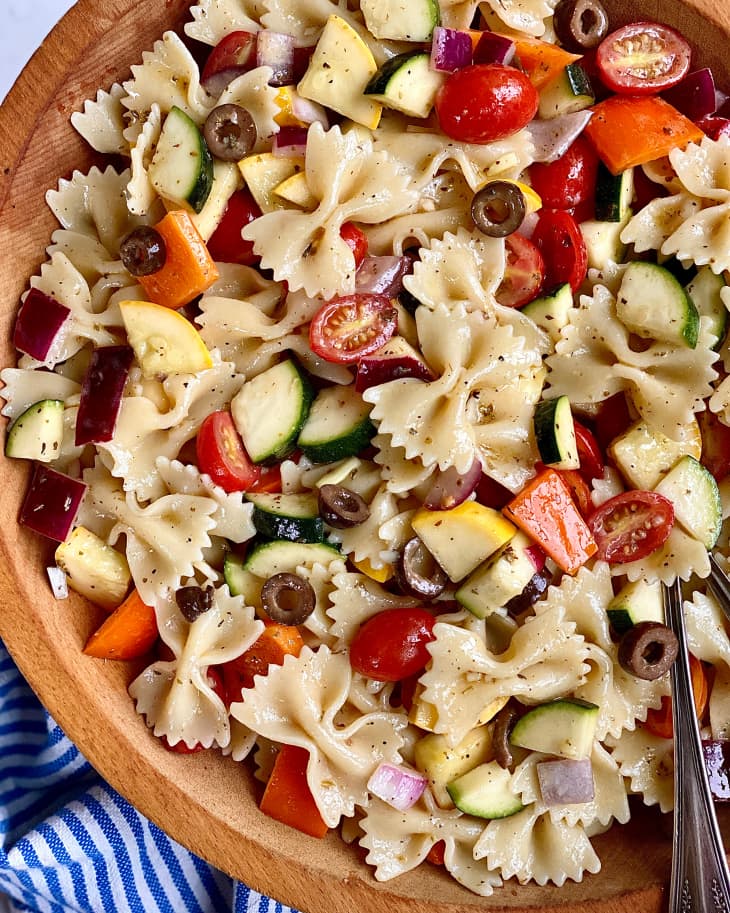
[{"left": 547, "top": 285, "right": 717, "bottom": 439}]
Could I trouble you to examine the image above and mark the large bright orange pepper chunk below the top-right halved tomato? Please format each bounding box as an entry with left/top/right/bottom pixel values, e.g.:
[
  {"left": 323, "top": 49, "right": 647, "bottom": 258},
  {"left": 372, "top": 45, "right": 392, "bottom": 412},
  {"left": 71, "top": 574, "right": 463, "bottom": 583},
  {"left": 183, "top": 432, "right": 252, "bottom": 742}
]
[{"left": 585, "top": 95, "right": 705, "bottom": 174}]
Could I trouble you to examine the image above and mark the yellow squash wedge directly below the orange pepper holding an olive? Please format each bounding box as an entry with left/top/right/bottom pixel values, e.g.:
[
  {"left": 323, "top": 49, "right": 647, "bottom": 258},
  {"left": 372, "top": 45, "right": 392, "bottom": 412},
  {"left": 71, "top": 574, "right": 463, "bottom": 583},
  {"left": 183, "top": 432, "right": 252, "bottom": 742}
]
[{"left": 119, "top": 301, "right": 213, "bottom": 377}]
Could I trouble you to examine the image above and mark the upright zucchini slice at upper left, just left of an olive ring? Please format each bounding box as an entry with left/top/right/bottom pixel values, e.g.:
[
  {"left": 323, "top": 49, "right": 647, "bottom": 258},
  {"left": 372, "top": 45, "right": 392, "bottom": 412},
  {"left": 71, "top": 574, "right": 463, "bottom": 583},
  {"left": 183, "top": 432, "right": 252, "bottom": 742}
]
[{"left": 149, "top": 105, "right": 213, "bottom": 213}]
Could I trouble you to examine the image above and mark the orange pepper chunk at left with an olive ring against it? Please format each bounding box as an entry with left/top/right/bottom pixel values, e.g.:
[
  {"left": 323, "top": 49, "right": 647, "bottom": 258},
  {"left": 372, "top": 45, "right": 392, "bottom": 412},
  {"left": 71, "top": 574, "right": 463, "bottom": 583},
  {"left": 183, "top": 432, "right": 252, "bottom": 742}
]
[{"left": 139, "top": 209, "right": 219, "bottom": 308}]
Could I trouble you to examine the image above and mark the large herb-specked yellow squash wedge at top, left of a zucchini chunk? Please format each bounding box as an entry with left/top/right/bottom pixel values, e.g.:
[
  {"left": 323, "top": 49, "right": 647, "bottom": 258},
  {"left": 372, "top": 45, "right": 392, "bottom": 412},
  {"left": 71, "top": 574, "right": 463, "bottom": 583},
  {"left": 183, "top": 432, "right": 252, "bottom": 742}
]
[{"left": 297, "top": 15, "right": 383, "bottom": 130}]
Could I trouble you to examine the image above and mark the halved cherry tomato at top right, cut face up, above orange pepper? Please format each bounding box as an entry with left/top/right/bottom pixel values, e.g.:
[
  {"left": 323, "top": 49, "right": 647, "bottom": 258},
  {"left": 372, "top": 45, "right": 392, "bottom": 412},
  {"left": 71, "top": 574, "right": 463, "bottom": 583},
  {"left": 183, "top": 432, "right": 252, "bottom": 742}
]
[{"left": 596, "top": 22, "right": 692, "bottom": 95}]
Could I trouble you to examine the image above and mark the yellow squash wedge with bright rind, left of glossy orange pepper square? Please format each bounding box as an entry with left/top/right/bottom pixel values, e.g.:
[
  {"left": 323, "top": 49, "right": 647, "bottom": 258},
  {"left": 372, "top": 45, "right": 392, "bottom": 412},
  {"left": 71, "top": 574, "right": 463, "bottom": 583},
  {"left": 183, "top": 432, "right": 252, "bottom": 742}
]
[{"left": 412, "top": 501, "right": 517, "bottom": 582}]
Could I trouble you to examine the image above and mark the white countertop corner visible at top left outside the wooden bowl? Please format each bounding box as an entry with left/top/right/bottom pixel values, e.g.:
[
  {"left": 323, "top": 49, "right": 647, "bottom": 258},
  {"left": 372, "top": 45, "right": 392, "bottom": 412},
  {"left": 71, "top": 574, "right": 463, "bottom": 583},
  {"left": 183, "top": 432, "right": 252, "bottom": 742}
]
[{"left": 0, "top": 0, "right": 75, "bottom": 101}]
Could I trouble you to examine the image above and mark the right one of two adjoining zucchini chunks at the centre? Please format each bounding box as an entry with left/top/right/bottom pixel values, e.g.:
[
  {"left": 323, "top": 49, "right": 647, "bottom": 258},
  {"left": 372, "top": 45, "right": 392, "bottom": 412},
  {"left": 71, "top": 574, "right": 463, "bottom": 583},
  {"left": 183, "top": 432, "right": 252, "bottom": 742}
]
[{"left": 297, "top": 384, "right": 375, "bottom": 463}]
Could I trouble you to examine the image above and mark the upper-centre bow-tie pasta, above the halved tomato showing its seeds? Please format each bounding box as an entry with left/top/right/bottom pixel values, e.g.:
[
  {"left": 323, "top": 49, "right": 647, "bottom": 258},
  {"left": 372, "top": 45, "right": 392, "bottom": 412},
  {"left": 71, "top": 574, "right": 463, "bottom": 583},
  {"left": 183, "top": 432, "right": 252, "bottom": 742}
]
[{"left": 243, "top": 123, "right": 418, "bottom": 299}]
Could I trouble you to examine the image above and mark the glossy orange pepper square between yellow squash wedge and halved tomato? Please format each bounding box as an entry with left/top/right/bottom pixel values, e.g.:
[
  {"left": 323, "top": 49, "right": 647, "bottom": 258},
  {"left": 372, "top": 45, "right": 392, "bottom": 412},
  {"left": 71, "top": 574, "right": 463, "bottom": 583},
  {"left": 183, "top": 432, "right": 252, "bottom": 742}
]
[{"left": 502, "top": 468, "right": 598, "bottom": 574}]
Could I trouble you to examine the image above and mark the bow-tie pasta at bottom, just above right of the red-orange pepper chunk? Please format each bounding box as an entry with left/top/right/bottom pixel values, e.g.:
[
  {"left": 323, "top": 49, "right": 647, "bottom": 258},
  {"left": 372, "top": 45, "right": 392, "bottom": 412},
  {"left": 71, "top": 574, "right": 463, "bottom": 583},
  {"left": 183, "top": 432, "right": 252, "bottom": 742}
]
[{"left": 231, "top": 646, "right": 407, "bottom": 827}]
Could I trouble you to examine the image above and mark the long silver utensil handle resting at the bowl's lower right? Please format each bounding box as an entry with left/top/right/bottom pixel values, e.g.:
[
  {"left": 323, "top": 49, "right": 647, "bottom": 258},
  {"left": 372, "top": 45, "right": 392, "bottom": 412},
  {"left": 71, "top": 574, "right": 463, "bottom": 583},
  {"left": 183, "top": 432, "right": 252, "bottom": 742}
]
[{"left": 664, "top": 578, "right": 730, "bottom": 913}]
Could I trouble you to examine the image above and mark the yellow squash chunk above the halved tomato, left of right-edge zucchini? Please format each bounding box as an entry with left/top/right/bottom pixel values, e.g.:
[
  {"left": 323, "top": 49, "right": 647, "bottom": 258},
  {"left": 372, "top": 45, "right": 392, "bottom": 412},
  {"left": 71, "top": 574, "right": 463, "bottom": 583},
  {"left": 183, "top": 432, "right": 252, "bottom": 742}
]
[{"left": 608, "top": 420, "right": 702, "bottom": 490}]
